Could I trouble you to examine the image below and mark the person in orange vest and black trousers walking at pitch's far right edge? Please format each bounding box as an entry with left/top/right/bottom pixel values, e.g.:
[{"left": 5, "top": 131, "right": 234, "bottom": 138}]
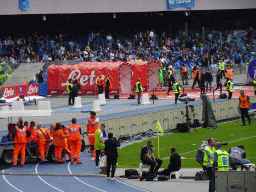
[{"left": 238, "top": 91, "right": 252, "bottom": 126}]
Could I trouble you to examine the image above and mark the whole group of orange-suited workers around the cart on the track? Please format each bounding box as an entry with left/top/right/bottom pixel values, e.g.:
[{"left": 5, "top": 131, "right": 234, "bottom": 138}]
[{"left": 11, "top": 111, "right": 99, "bottom": 167}]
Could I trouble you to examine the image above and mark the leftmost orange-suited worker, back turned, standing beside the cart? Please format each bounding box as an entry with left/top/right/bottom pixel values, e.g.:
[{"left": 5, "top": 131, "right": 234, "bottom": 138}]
[{"left": 12, "top": 120, "right": 31, "bottom": 167}]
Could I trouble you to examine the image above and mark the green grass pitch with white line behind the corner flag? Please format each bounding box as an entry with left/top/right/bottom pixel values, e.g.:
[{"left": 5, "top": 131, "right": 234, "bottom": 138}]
[{"left": 118, "top": 119, "right": 256, "bottom": 168}]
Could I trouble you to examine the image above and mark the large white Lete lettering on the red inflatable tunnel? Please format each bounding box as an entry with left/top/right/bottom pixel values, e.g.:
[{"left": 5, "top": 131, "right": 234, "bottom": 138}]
[{"left": 61, "top": 70, "right": 105, "bottom": 87}]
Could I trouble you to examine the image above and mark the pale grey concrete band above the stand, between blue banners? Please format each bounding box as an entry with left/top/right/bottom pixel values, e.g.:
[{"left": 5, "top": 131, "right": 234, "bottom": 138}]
[{"left": 0, "top": 0, "right": 256, "bottom": 15}]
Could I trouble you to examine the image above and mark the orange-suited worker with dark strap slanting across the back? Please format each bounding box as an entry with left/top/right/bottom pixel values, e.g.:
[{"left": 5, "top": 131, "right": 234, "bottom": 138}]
[{"left": 35, "top": 123, "right": 50, "bottom": 164}]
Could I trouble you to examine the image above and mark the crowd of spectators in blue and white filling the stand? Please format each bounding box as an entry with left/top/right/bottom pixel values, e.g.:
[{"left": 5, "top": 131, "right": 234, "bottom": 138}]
[{"left": 0, "top": 29, "right": 256, "bottom": 69}]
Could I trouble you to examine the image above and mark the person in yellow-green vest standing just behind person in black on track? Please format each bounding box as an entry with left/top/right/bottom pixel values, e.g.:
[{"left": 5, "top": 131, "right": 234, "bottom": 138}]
[{"left": 95, "top": 124, "right": 105, "bottom": 169}]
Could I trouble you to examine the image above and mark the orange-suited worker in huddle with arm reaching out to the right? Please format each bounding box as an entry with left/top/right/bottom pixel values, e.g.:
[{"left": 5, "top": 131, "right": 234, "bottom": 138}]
[{"left": 52, "top": 123, "right": 69, "bottom": 163}]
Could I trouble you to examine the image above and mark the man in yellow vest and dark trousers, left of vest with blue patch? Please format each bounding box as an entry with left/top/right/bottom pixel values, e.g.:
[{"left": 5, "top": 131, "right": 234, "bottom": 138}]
[{"left": 203, "top": 138, "right": 215, "bottom": 192}]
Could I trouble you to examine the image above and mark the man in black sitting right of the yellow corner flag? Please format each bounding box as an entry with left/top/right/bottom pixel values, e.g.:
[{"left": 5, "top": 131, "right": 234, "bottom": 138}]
[{"left": 157, "top": 147, "right": 181, "bottom": 176}]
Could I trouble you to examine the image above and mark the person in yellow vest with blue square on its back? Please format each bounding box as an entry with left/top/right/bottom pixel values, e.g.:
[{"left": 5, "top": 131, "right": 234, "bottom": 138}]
[{"left": 212, "top": 142, "right": 229, "bottom": 191}]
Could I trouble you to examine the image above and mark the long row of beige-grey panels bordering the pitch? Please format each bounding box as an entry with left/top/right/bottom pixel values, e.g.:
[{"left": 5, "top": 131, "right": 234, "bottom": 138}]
[{"left": 81, "top": 96, "right": 256, "bottom": 144}]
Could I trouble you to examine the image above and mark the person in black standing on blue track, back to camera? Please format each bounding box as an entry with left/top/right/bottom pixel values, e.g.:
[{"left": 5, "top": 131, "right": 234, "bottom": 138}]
[{"left": 105, "top": 133, "right": 120, "bottom": 180}]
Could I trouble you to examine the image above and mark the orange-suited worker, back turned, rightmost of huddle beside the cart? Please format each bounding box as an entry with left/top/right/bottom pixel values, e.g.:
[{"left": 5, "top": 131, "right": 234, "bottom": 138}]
[{"left": 68, "top": 118, "right": 82, "bottom": 164}]
